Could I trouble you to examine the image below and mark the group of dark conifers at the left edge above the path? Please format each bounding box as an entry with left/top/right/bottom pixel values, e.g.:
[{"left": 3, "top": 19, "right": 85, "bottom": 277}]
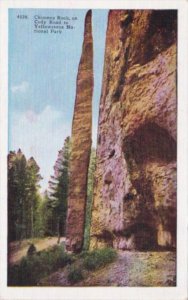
[{"left": 8, "top": 149, "right": 41, "bottom": 241}]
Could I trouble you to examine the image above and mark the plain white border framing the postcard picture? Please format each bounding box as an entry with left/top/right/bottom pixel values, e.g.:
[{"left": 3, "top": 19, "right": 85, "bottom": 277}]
[{"left": 0, "top": 0, "right": 188, "bottom": 300}]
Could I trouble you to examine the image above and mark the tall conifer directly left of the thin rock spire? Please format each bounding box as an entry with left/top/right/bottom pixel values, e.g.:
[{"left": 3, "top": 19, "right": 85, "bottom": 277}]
[{"left": 48, "top": 137, "right": 70, "bottom": 241}]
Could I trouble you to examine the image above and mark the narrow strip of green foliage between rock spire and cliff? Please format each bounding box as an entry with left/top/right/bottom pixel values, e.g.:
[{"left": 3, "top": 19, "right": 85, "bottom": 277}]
[{"left": 83, "top": 148, "right": 96, "bottom": 250}]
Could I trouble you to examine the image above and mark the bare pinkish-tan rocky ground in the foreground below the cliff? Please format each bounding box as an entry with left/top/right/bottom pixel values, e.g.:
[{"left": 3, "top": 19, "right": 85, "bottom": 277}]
[{"left": 40, "top": 251, "right": 176, "bottom": 287}]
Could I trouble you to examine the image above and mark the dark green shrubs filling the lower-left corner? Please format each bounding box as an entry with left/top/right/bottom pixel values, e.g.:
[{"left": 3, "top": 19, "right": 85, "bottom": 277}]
[{"left": 8, "top": 246, "right": 72, "bottom": 286}]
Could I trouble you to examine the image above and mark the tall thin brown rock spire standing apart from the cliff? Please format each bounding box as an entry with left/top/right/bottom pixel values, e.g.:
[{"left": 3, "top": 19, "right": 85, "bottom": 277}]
[{"left": 66, "top": 11, "right": 93, "bottom": 252}]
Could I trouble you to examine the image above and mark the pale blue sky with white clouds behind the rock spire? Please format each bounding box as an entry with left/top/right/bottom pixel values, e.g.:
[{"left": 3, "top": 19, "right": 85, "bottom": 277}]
[{"left": 8, "top": 9, "right": 108, "bottom": 191}]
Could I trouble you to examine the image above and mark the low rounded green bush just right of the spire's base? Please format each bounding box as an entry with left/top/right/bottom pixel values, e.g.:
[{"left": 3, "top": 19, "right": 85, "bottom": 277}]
[{"left": 83, "top": 248, "right": 117, "bottom": 270}]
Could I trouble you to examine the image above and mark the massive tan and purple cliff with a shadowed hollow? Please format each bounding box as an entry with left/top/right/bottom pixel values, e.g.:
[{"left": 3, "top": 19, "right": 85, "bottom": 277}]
[{"left": 90, "top": 10, "right": 177, "bottom": 250}]
